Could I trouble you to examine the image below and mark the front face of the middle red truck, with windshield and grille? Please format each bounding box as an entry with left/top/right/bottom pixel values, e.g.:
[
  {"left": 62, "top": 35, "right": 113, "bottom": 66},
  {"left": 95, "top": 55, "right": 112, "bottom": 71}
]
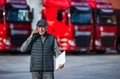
[{"left": 70, "top": 0, "right": 94, "bottom": 52}]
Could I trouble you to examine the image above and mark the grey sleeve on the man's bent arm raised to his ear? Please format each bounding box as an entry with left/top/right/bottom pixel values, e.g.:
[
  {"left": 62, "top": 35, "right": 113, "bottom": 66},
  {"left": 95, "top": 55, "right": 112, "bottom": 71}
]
[{"left": 21, "top": 38, "right": 32, "bottom": 52}]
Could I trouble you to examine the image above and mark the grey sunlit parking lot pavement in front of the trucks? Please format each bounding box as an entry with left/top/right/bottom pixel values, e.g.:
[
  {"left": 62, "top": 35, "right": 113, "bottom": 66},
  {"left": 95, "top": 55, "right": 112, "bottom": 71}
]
[{"left": 0, "top": 54, "right": 120, "bottom": 79}]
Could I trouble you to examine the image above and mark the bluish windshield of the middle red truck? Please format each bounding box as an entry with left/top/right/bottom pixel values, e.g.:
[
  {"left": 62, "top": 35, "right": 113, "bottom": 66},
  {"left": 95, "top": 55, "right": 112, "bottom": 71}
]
[{"left": 71, "top": 11, "right": 92, "bottom": 25}]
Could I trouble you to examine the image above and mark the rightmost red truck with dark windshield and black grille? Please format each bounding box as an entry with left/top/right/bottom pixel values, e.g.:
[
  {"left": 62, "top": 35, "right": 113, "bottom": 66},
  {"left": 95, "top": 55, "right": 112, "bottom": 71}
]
[{"left": 88, "top": 0, "right": 118, "bottom": 53}]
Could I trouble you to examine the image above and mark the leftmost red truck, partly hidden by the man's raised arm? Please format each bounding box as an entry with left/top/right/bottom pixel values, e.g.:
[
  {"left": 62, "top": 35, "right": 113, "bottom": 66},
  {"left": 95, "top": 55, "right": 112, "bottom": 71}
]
[{"left": 0, "top": 0, "right": 32, "bottom": 51}]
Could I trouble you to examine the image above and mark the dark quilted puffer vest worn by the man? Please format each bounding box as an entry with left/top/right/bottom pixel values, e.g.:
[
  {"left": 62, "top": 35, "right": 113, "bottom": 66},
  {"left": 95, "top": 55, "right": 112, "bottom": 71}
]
[{"left": 30, "top": 34, "right": 55, "bottom": 72}]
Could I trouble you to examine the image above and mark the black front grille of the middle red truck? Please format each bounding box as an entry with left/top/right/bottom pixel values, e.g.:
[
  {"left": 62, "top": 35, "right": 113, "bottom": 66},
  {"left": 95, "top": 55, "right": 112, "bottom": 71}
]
[{"left": 75, "top": 36, "right": 90, "bottom": 47}]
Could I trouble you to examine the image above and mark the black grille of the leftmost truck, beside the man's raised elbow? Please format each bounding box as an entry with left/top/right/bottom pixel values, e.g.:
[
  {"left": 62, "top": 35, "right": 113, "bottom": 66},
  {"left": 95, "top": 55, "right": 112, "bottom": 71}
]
[{"left": 11, "top": 34, "right": 28, "bottom": 46}]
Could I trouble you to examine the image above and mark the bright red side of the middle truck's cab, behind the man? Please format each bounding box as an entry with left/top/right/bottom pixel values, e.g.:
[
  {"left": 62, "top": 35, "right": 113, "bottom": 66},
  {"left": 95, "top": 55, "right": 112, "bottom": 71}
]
[{"left": 42, "top": 0, "right": 76, "bottom": 52}]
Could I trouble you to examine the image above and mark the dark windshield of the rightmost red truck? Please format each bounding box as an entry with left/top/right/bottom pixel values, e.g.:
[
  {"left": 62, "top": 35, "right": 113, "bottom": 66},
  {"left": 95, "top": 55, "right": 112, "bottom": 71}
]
[{"left": 96, "top": 11, "right": 117, "bottom": 26}]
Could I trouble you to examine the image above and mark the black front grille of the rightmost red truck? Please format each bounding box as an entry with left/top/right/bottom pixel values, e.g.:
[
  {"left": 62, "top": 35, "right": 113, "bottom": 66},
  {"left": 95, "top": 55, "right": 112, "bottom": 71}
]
[{"left": 101, "top": 36, "right": 115, "bottom": 47}]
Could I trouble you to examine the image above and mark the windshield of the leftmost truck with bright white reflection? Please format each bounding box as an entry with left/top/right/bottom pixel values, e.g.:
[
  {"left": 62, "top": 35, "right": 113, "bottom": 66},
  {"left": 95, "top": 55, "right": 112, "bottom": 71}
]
[{"left": 6, "top": 9, "right": 30, "bottom": 22}]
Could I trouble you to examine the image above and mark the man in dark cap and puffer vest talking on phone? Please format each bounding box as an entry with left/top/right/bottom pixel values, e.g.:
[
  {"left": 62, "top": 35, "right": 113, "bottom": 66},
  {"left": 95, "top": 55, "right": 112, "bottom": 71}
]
[{"left": 21, "top": 19, "right": 63, "bottom": 79}]
